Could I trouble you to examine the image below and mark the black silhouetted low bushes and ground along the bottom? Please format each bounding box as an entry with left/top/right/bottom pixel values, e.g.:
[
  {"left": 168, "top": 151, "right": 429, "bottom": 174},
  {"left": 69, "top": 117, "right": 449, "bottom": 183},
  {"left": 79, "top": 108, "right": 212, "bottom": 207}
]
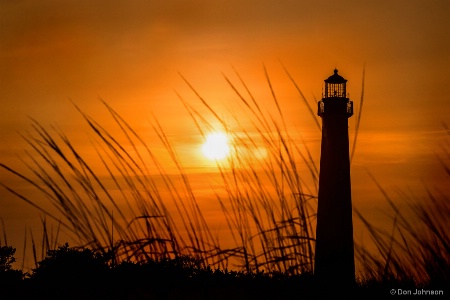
[{"left": 0, "top": 244, "right": 448, "bottom": 299}]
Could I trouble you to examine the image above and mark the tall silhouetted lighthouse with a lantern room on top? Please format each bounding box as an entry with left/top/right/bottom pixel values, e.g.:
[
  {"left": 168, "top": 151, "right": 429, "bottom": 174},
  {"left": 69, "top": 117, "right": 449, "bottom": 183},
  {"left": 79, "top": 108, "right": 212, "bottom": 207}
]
[{"left": 314, "top": 69, "right": 355, "bottom": 285}]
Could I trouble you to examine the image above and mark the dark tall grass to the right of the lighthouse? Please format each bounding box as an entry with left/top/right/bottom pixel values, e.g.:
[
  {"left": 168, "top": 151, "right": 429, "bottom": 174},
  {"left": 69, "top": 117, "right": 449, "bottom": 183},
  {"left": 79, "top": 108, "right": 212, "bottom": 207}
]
[{"left": 355, "top": 124, "right": 450, "bottom": 288}]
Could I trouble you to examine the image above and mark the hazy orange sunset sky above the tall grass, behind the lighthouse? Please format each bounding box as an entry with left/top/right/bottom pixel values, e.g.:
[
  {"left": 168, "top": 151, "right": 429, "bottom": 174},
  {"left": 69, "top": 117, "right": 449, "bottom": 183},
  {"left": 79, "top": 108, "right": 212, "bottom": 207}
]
[{"left": 0, "top": 0, "right": 450, "bottom": 268}]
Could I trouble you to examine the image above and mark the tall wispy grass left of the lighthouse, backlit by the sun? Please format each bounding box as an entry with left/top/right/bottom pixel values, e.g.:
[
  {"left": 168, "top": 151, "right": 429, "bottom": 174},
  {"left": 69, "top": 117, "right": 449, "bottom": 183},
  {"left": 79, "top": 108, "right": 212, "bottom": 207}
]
[{"left": 0, "top": 68, "right": 324, "bottom": 274}]
